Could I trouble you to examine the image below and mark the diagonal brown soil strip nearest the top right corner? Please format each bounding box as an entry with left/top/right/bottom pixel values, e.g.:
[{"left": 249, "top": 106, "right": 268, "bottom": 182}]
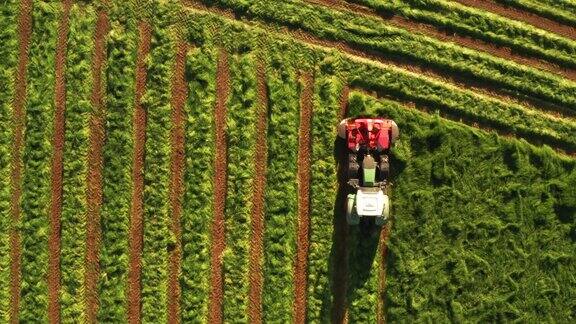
[{"left": 456, "top": 0, "right": 576, "bottom": 40}]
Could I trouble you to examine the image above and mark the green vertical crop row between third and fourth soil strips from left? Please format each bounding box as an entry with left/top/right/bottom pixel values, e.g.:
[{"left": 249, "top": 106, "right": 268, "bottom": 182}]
[{"left": 97, "top": 0, "right": 138, "bottom": 322}]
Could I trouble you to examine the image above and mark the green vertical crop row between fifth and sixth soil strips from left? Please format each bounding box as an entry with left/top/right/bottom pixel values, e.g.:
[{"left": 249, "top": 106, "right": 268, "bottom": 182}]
[{"left": 180, "top": 46, "right": 217, "bottom": 323}]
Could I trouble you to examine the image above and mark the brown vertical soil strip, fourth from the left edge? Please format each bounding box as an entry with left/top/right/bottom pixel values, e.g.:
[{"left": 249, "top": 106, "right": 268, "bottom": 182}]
[{"left": 128, "top": 22, "right": 152, "bottom": 323}]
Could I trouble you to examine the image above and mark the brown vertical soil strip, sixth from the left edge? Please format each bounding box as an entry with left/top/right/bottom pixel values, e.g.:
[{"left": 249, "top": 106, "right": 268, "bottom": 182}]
[{"left": 208, "top": 50, "right": 230, "bottom": 323}]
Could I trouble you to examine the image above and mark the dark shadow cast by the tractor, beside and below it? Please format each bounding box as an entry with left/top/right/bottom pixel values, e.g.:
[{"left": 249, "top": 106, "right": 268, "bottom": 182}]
[{"left": 329, "top": 137, "right": 382, "bottom": 323}]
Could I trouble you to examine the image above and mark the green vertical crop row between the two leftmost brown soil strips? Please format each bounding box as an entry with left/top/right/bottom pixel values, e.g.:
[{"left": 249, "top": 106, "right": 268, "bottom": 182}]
[{"left": 20, "top": 1, "right": 62, "bottom": 322}]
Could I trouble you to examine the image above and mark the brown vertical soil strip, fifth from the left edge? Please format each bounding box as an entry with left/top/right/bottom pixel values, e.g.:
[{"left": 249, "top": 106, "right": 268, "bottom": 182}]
[{"left": 167, "top": 42, "right": 188, "bottom": 323}]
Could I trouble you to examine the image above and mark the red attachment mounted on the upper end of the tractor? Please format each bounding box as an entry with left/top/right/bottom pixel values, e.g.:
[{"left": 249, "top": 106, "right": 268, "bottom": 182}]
[{"left": 338, "top": 118, "right": 398, "bottom": 152}]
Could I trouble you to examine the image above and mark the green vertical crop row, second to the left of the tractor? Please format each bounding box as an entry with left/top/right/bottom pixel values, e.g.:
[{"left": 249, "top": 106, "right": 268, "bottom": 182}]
[{"left": 262, "top": 52, "right": 301, "bottom": 323}]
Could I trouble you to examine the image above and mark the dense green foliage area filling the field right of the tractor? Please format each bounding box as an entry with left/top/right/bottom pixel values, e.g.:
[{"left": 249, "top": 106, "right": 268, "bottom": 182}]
[{"left": 351, "top": 94, "right": 576, "bottom": 322}]
